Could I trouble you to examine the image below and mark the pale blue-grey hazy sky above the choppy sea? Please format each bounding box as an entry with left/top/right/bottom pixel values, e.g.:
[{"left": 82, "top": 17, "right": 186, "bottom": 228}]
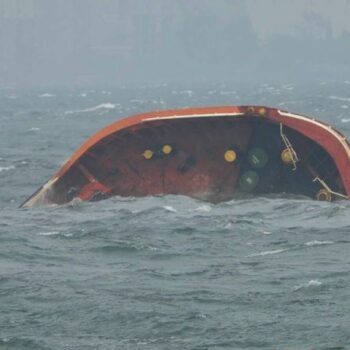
[{"left": 0, "top": 0, "right": 350, "bottom": 86}]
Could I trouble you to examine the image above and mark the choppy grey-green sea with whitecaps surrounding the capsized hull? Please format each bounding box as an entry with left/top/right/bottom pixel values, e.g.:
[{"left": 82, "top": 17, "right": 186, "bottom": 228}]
[{"left": 0, "top": 81, "right": 350, "bottom": 350}]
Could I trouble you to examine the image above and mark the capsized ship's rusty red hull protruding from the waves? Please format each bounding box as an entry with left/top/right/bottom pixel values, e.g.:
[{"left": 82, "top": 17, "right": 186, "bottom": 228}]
[{"left": 22, "top": 106, "right": 350, "bottom": 207}]
